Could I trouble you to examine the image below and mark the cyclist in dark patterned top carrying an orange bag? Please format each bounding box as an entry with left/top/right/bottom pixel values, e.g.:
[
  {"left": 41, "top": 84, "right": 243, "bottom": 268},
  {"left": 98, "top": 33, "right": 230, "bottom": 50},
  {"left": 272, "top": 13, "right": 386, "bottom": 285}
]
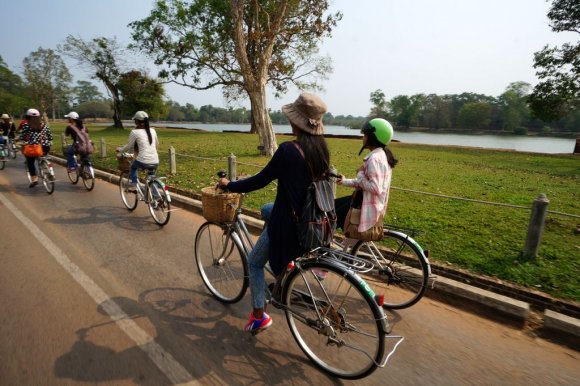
[{"left": 20, "top": 109, "right": 52, "bottom": 188}]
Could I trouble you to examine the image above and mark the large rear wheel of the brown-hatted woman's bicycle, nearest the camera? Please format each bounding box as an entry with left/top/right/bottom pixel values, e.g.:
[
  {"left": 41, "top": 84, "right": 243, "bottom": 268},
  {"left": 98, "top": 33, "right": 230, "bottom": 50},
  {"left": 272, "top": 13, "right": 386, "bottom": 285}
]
[{"left": 282, "top": 260, "right": 387, "bottom": 379}]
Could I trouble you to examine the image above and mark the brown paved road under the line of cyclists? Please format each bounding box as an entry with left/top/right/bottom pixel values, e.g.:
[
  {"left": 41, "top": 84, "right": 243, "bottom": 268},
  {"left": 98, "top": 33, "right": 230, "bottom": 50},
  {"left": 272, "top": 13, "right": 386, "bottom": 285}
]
[{"left": 0, "top": 158, "right": 580, "bottom": 385}]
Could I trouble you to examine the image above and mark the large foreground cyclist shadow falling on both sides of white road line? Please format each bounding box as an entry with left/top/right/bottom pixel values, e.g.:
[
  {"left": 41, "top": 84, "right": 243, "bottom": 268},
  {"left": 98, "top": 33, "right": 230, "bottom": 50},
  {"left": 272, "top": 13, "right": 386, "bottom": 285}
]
[{"left": 54, "top": 288, "right": 342, "bottom": 385}]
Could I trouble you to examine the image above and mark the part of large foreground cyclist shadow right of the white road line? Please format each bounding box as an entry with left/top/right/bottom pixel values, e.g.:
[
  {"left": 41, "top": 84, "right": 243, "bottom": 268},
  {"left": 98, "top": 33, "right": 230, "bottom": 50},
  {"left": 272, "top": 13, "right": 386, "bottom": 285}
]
[{"left": 139, "top": 288, "right": 341, "bottom": 384}]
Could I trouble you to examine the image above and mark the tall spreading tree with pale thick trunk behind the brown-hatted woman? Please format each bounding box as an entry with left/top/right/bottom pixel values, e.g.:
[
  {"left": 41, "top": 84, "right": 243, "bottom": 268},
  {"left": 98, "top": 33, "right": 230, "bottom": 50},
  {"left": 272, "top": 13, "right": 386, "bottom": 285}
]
[{"left": 130, "top": 0, "right": 342, "bottom": 155}]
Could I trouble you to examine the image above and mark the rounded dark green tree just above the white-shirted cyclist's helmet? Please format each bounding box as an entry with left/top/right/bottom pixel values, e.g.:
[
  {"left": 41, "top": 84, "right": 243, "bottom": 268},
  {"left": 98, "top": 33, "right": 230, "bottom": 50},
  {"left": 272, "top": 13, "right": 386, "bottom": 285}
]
[{"left": 117, "top": 70, "right": 167, "bottom": 119}]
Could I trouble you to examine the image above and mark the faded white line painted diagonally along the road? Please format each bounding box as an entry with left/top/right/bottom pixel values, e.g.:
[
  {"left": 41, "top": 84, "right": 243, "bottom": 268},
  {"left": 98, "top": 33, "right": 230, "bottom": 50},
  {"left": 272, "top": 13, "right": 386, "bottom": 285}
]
[{"left": 0, "top": 193, "right": 208, "bottom": 385}]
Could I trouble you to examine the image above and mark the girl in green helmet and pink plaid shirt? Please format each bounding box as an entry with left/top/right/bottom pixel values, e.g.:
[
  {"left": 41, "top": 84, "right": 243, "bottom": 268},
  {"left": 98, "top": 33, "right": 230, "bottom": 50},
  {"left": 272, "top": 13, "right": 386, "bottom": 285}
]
[{"left": 335, "top": 118, "right": 398, "bottom": 237}]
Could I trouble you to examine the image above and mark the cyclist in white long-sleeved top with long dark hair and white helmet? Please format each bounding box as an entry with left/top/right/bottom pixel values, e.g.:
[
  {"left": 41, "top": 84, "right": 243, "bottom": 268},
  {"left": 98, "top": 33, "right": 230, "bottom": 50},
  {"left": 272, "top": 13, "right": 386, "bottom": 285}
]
[{"left": 117, "top": 111, "right": 159, "bottom": 187}]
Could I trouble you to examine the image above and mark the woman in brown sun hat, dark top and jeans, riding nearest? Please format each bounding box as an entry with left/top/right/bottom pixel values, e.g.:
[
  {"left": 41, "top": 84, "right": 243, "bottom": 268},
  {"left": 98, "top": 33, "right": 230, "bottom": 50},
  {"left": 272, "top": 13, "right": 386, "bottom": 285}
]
[{"left": 219, "top": 93, "right": 330, "bottom": 333}]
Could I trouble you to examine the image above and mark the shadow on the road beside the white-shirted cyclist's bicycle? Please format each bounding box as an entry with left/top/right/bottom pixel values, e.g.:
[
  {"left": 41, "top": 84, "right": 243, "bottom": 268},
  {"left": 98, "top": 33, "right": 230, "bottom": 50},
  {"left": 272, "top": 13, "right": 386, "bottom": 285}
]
[{"left": 46, "top": 206, "right": 162, "bottom": 232}]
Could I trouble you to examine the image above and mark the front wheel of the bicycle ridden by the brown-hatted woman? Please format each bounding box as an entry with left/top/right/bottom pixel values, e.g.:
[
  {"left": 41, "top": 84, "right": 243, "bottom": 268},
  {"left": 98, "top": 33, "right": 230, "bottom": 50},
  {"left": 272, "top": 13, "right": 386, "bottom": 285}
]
[{"left": 194, "top": 222, "right": 250, "bottom": 303}]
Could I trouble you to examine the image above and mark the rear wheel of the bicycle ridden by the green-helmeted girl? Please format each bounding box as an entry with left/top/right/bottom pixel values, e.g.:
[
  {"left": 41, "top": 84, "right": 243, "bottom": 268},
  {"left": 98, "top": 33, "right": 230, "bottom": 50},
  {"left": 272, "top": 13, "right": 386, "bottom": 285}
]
[{"left": 351, "top": 230, "right": 429, "bottom": 309}]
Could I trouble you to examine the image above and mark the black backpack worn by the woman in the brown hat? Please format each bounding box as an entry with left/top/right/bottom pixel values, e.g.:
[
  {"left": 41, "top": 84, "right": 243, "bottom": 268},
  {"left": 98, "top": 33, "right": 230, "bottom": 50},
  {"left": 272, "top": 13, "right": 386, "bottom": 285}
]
[{"left": 293, "top": 142, "right": 336, "bottom": 250}]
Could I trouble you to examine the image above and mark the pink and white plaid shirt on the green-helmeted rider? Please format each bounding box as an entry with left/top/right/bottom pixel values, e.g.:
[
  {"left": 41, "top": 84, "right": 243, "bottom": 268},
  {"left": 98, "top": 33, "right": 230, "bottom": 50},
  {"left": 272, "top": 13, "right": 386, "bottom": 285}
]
[{"left": 342, "top": 148, "right": 393, "bottom": 232}]
